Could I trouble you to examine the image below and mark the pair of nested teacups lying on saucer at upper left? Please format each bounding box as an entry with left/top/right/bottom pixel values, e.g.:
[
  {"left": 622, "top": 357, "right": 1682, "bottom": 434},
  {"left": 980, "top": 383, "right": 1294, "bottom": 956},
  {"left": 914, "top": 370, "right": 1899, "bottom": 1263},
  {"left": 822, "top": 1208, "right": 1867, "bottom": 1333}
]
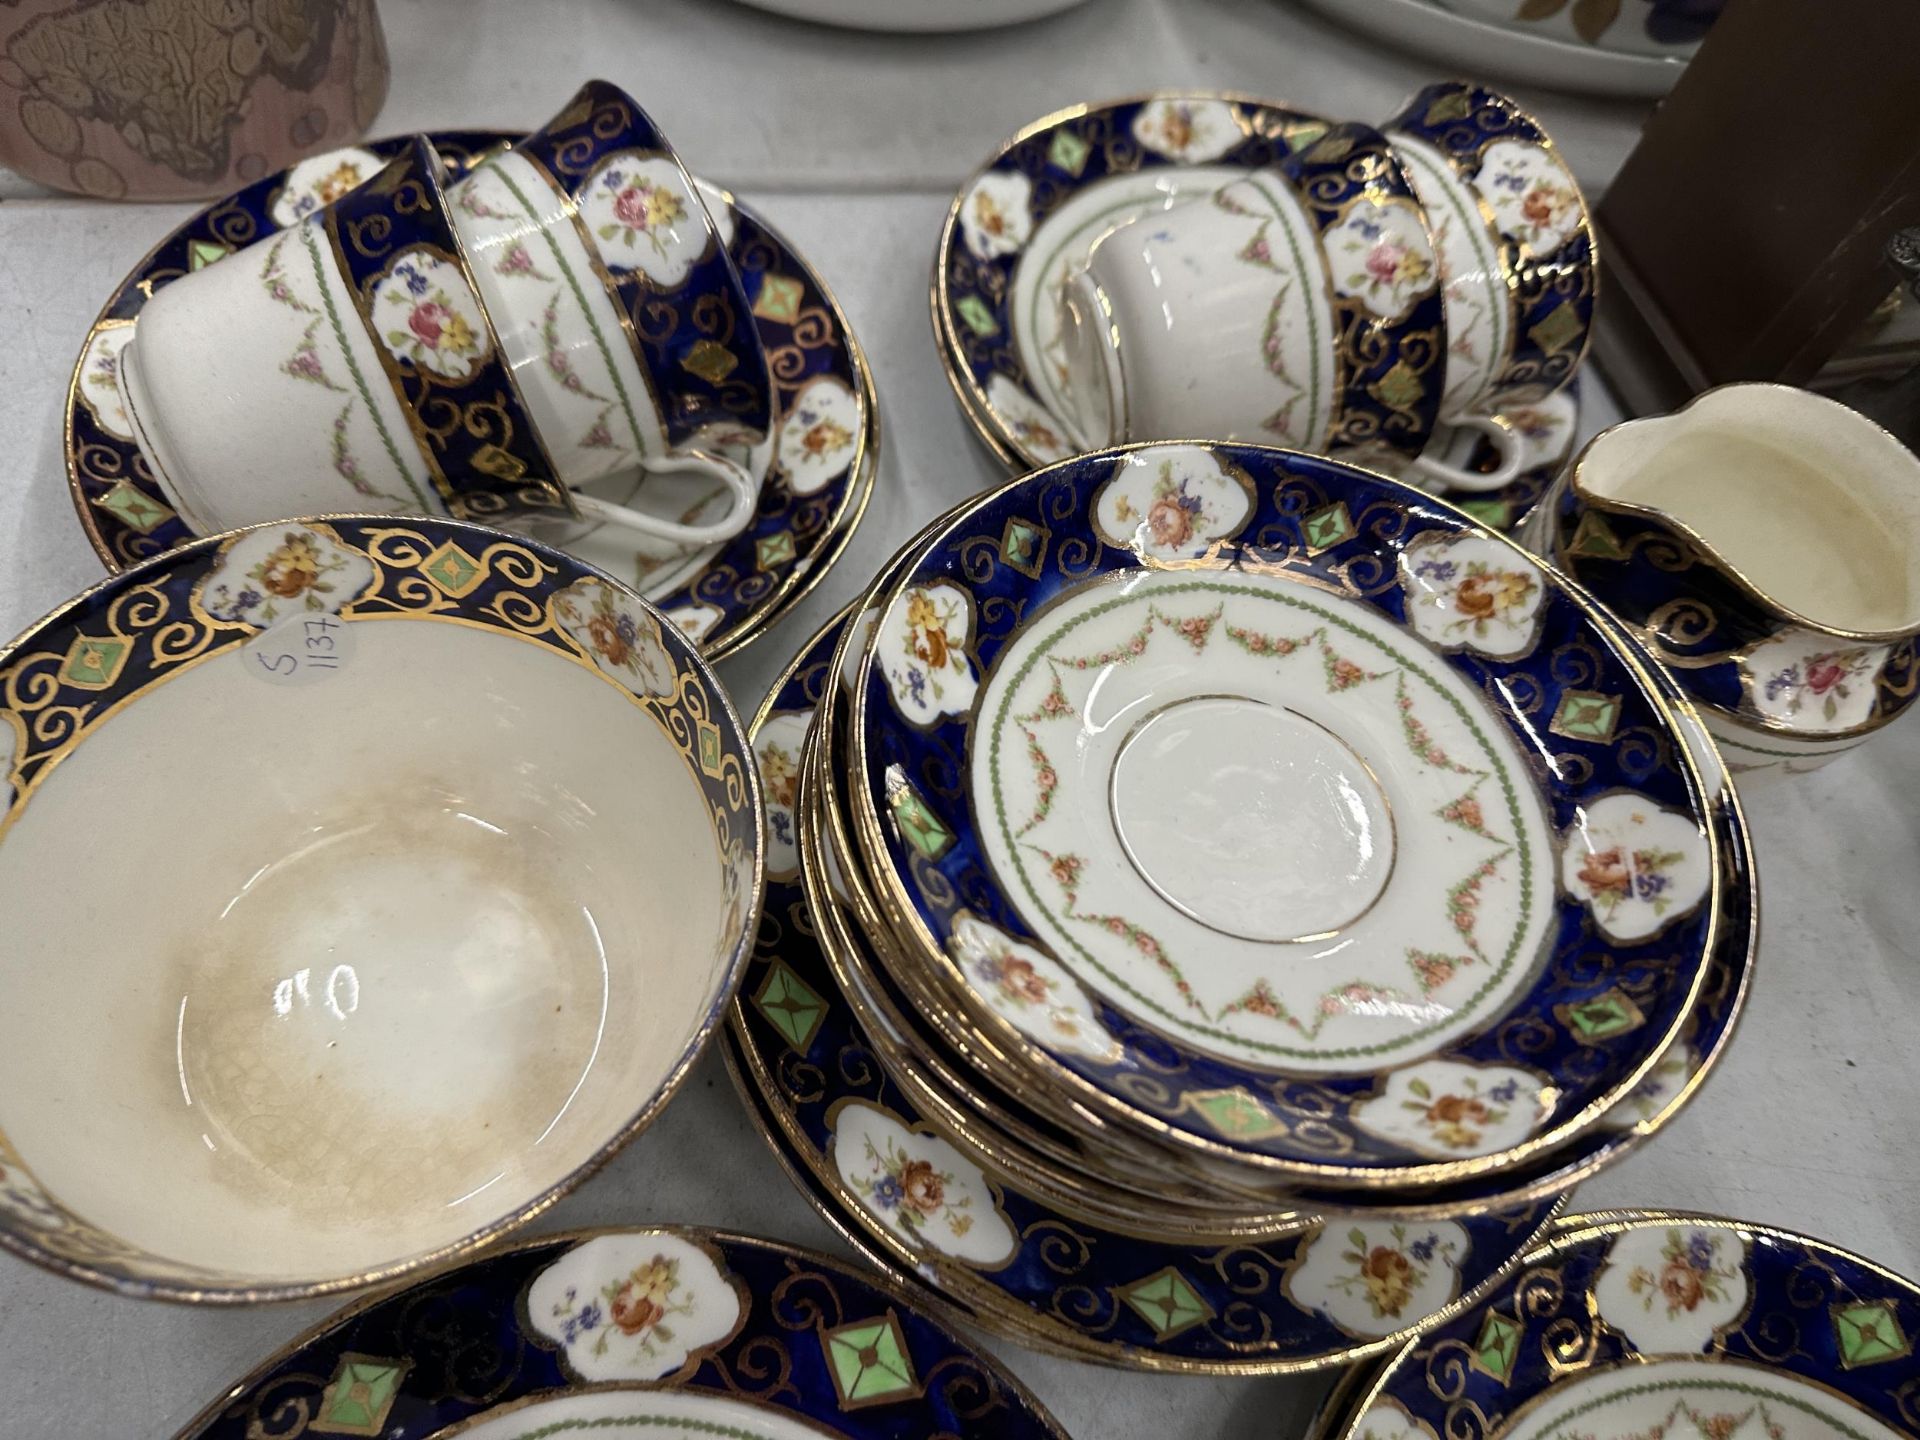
[{"left": 119, "top": 81, "right": 772, "bottom": 543}]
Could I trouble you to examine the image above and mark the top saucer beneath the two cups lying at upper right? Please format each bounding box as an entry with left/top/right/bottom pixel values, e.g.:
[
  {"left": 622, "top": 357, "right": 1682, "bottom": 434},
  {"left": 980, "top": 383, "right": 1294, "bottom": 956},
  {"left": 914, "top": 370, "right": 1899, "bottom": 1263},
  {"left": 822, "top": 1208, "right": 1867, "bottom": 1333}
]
[{"left": 931, "top": 92, "right": 1578, "bottom": 530}]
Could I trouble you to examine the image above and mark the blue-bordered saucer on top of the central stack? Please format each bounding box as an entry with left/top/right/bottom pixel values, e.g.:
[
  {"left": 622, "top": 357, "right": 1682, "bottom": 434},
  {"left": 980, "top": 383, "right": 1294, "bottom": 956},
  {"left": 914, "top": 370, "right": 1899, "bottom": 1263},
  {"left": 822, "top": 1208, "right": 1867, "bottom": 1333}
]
[{"left": 841, "top": 445, "right": 1724, "bottom": 1202}]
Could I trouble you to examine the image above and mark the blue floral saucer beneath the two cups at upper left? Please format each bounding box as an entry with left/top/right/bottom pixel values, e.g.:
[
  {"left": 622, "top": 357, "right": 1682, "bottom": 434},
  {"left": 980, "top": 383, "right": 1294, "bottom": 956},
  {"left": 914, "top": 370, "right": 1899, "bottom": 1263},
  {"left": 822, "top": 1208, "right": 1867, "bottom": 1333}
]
[{"left": 65, "top": 131, "right": 879, "bottom": 659}]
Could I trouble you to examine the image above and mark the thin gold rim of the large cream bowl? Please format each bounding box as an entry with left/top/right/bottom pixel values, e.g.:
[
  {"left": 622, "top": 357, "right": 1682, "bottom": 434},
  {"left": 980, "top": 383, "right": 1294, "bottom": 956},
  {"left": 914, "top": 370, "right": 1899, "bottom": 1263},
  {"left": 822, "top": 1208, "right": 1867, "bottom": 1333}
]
[{"left": 0, "top": 513, "right": 766, "bottom": 1306}]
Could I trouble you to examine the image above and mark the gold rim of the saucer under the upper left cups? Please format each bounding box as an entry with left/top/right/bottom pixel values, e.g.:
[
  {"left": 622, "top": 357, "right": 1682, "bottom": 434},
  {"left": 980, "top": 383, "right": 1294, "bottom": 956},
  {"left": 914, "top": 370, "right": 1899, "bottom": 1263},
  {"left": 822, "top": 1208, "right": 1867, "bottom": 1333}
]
[{"left": 61, "top": 141, "right": 881, "bottom": 662}]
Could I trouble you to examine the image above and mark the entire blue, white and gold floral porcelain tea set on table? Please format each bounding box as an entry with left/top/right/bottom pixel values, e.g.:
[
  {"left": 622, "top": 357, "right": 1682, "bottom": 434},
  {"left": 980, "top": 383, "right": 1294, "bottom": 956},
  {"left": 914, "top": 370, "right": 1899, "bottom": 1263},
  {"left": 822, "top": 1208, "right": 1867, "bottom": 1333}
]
[{"left": 0, "top": 73, "right": 1920, "bottom": 1440}]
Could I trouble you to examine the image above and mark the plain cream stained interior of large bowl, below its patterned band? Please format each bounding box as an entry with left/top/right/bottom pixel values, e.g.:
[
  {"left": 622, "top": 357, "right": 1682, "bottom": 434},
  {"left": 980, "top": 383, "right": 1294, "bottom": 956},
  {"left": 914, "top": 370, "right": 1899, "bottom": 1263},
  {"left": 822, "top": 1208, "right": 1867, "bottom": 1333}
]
[{"left": 0, "top": 591, "right": 739, "bottom": 1283}]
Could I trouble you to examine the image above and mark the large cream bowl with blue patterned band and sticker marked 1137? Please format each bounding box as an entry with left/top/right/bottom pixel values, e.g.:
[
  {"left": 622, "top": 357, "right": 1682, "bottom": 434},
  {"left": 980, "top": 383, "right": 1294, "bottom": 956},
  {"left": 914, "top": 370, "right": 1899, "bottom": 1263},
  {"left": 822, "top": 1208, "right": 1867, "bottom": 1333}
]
[{"left": 0, "top": 514, "right": 764, "bottom": 1302}]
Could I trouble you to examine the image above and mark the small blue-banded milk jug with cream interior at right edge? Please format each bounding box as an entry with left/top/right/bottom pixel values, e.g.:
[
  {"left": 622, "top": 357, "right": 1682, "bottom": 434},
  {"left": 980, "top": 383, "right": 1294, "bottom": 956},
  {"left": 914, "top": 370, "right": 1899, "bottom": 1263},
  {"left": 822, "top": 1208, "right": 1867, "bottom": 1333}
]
[{"left": 1526, "top": 384, "right": 1920, "bottom": 772}]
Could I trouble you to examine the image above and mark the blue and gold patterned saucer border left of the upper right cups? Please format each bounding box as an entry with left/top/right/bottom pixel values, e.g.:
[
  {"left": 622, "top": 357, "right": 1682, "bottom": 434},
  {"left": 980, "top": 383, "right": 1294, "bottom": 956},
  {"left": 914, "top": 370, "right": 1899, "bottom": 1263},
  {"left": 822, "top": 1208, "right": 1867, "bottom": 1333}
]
[{"left": 933, "top": 92, "right": 1327, "bottom": 468}]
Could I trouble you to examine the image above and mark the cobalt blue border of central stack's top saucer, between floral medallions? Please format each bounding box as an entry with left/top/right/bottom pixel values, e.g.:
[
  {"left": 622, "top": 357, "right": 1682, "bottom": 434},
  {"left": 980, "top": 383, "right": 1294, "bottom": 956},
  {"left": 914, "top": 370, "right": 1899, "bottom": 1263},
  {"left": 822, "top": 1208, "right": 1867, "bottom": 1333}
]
[{"left": 856, "top": 445, "right": 1711, "bottom": 1169}]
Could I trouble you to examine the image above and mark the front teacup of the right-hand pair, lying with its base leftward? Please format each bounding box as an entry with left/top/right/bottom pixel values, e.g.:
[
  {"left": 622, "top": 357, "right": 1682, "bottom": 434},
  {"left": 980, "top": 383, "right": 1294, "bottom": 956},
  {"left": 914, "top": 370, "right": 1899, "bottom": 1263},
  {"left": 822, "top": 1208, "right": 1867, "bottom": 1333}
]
[{"left": 1062, "top": 125, "right": 1521, "bottom": 488}]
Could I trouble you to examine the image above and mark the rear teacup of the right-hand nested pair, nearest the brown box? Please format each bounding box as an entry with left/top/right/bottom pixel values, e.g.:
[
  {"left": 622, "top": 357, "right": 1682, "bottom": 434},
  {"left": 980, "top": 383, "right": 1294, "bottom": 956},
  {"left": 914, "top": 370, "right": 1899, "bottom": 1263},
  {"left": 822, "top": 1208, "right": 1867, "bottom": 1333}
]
[{"left": 1380, "top": 81, "right": 1599, "bottom": 411}]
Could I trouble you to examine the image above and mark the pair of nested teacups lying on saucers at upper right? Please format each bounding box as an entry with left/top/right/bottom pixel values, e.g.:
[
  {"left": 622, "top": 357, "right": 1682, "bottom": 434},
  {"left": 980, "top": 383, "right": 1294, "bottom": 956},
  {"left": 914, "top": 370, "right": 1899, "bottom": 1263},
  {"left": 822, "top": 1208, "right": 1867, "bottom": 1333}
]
[{"left": 1062, "top": 83, "right": 1597, "bottom": 492}]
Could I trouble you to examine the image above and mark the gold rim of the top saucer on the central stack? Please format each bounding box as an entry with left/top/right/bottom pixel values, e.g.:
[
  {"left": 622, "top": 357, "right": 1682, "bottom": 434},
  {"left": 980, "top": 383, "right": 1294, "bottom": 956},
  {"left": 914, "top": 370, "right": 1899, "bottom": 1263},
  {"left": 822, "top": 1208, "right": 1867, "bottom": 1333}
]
[{"left": 837, "top": 440, "right": 1724, "bottom": 1190}]
